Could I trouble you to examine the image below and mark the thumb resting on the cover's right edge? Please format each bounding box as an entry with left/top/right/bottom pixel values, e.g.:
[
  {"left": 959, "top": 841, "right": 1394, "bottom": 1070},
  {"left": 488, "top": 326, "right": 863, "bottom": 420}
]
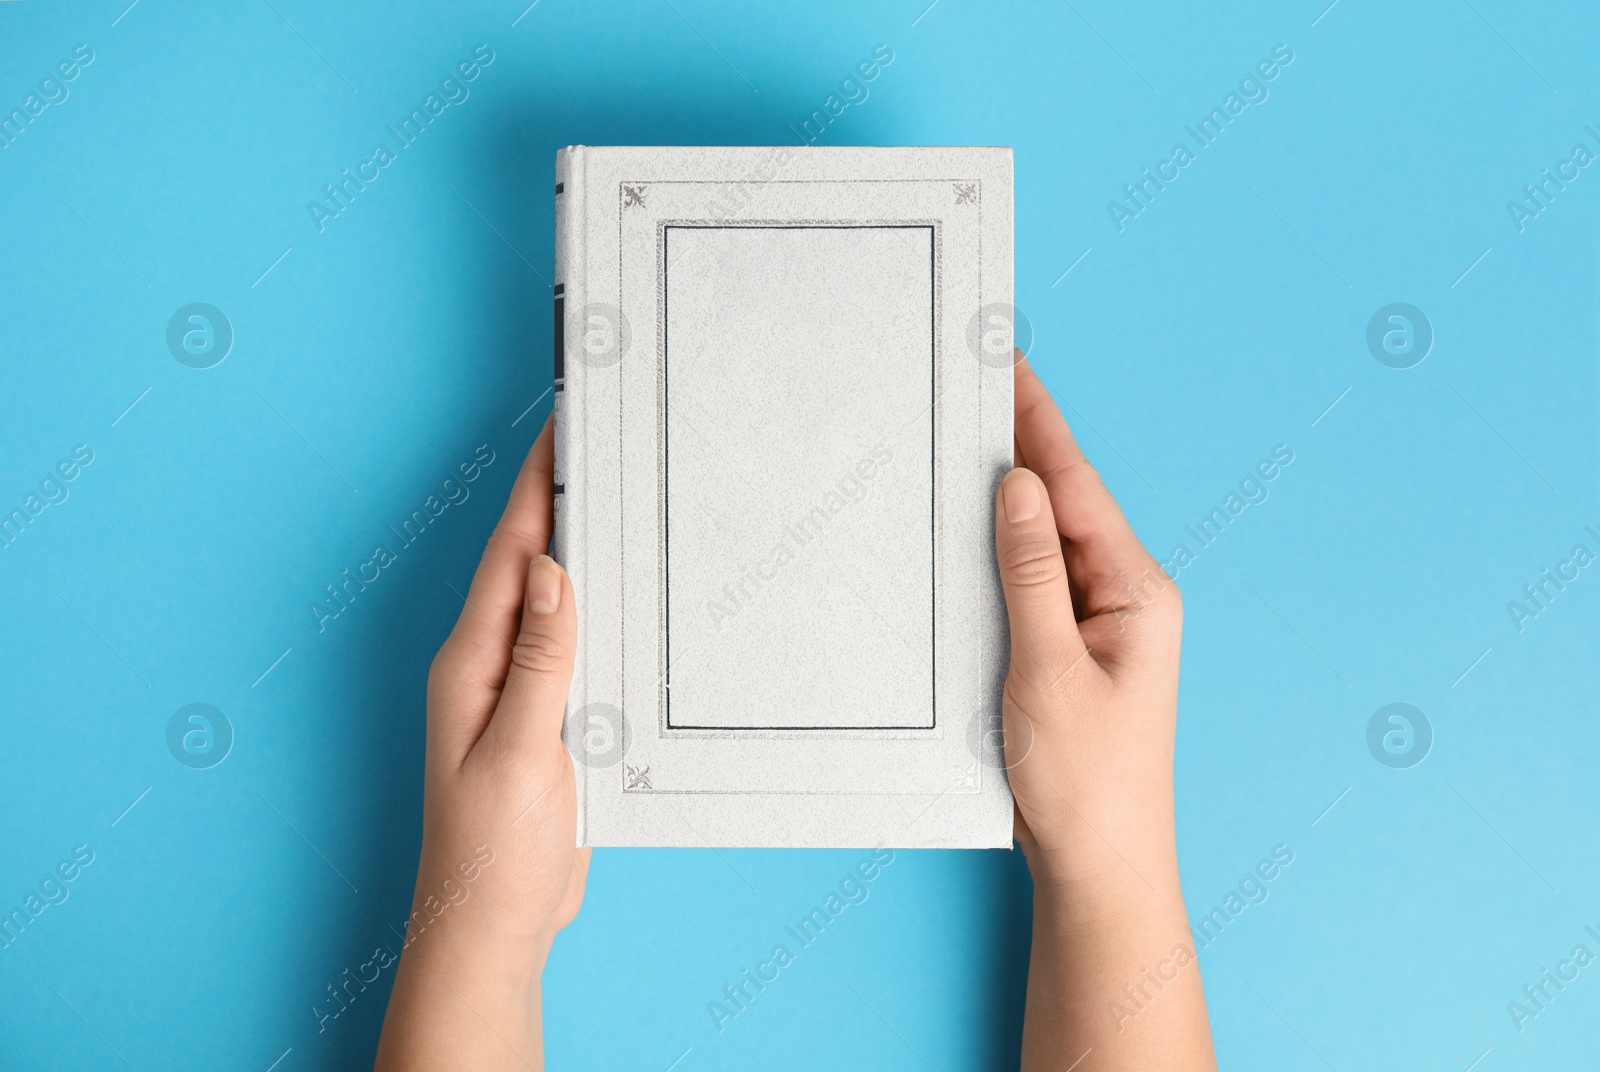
[{"left": 995, "top": 469, "right": 1088, "bottom": 694}]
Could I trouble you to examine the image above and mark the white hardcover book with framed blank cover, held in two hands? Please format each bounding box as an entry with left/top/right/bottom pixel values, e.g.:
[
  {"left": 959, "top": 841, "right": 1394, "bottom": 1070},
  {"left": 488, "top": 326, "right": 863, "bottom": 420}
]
[{"left": 554, "top": 146, "right": 1014, "bottom": 848}]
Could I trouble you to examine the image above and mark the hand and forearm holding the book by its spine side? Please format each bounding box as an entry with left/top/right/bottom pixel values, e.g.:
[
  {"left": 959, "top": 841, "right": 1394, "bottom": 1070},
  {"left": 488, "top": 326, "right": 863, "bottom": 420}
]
[{"left": 376, "top": 421, "right": 589, "bottom": 1072}]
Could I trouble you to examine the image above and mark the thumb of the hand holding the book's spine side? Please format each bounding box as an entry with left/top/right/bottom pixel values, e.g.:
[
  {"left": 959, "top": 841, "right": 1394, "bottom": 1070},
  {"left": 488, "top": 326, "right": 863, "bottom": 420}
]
[{"left": 483, "top": 555, "right": 578, "bottom": 755}]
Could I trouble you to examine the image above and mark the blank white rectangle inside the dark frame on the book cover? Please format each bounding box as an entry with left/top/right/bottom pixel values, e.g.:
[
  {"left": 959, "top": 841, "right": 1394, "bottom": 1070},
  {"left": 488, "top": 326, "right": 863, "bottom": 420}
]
[{"left": 662, "top": 224, "right": 936, "bottom": 730}]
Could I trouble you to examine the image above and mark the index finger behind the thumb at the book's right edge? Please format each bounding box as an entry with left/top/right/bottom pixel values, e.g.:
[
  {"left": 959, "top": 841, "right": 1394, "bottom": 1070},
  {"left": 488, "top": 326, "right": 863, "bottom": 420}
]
[{"left": 1016, "top": 362, "right": 1155, "bottom": 616}]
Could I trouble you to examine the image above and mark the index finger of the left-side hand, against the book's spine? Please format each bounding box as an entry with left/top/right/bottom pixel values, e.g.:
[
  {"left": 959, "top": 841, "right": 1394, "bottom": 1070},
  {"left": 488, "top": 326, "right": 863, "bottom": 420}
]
[{"left": 430, "top": 418, "right": 555, "bottom": 758}]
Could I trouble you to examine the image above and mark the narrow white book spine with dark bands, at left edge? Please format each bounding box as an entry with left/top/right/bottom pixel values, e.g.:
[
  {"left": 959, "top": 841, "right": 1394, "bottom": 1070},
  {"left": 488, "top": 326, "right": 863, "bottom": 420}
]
[{"left": 550, "top": 146, "right": 589, "bottom": 846}]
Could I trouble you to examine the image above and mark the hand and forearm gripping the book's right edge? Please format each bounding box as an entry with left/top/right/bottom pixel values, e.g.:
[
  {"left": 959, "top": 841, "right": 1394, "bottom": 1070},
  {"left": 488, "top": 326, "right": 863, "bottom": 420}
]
[{"left": 995, "top": 352, "right": 1216, "bottom": 1072}]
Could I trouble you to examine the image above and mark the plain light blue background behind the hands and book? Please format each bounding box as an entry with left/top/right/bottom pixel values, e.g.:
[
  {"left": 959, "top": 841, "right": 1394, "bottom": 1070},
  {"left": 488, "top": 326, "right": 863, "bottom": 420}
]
[{"left": 0, "top": 0, "right": 1600, "bottom": 1072}]
